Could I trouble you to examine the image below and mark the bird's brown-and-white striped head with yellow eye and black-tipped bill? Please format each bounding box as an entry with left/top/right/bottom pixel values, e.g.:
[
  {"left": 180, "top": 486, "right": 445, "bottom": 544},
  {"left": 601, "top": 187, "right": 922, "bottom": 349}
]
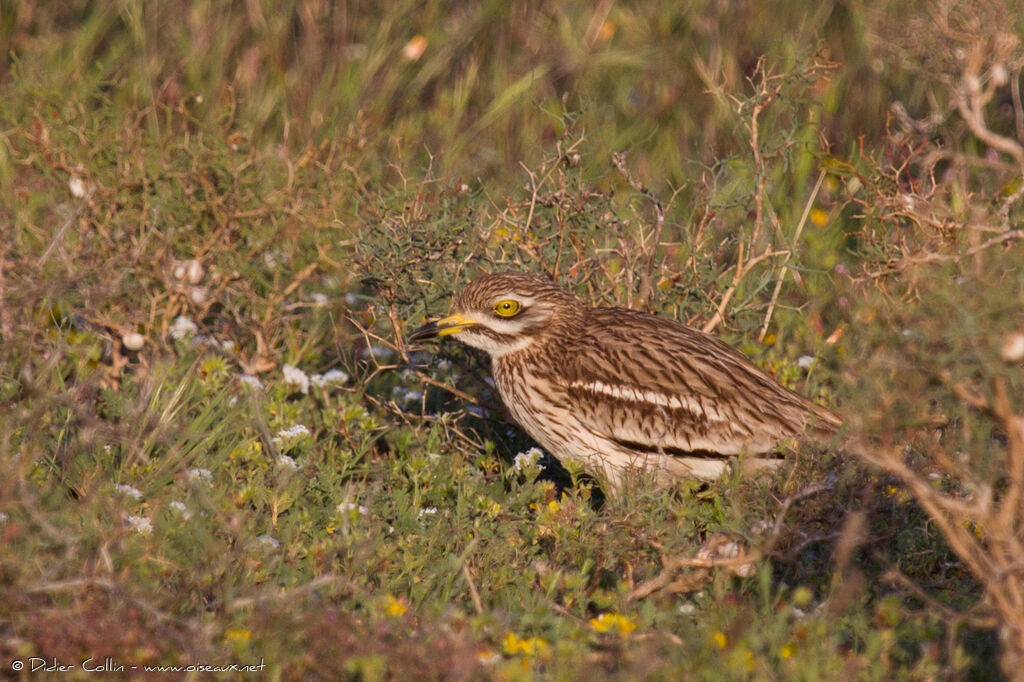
[{"left": 409, "top": 272, "right": 582, "bottom": 357}]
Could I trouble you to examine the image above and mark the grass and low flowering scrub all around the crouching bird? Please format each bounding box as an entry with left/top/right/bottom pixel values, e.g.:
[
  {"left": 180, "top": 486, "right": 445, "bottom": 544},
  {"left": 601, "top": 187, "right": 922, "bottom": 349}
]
[{"left": 0, "top": 1, "right": 1024, "bottom": 680}]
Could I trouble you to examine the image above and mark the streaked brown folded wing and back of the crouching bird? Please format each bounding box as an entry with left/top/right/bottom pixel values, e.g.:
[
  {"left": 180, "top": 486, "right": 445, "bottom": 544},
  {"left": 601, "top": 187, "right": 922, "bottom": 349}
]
[{"left": 562, "top": 308, "right": 840, "bottom": 459}]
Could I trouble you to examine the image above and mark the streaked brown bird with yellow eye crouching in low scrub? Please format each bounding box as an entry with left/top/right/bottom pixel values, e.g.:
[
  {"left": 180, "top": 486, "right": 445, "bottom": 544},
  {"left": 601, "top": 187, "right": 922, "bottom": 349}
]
[{"left": 409, "top": 271, "right": 842, "bottom": 493}]
